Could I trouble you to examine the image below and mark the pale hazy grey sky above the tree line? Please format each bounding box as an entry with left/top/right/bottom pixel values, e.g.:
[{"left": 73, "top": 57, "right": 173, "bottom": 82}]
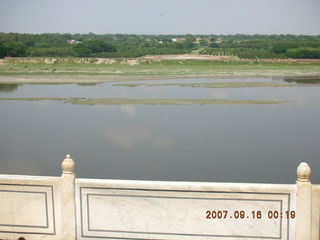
[{"left": 0, "top": 0, "right": 320, "bottom": 35}]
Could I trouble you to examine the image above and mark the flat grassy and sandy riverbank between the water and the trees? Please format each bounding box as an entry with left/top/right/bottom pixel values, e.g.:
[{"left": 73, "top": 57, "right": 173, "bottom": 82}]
[{"left": 0, "top": 58, "right": 320, "bottom": 83}]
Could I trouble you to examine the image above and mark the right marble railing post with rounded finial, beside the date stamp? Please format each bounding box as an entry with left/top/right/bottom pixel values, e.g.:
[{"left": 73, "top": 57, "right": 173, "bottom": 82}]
[{"left": 296, "top": 162, "right": 312, "bottom": 240}]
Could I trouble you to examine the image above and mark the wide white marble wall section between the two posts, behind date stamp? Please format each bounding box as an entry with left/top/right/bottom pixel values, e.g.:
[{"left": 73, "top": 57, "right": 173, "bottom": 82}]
[{"left": 76, "top": 179, "right": 296, "bottom": 240}]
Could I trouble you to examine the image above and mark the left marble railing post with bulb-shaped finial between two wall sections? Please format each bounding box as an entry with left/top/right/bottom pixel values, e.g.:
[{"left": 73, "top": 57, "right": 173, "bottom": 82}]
[{"left": 61, "top": 154, "right": 76, "bottom": 240}]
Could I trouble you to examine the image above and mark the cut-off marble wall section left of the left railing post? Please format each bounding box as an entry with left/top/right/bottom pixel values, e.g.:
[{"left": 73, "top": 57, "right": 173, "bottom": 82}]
[{"left": 0, "top": 175, "right": 60, "bottom": 239}]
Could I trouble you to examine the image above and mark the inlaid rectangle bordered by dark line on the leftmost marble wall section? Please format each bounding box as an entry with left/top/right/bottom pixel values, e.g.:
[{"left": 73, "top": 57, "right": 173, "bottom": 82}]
[{"left": 0, "top": 183, "right": 56, "bottom": 235}]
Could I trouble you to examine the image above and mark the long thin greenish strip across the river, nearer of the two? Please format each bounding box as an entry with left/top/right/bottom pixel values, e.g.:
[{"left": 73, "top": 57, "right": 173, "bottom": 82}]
[{"left": 0, "top": 98, "right": 291, "bottom": 105}]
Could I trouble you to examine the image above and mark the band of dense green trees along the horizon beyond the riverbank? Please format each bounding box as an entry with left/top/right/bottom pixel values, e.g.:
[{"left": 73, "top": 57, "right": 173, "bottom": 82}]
[{"left": 0, "top": 33, "right": 320, "bottom": 59}]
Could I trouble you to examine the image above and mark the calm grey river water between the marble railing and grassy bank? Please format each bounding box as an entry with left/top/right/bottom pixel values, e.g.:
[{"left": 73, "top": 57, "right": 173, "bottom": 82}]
[{"left": 0, "top": 79, "right": 320, "bottom": 183}]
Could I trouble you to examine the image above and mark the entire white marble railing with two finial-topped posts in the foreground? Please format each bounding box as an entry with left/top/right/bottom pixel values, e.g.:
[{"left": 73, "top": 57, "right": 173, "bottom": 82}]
[{"left": 0, "top": 155, "right": 320, "bottom": 240}]
